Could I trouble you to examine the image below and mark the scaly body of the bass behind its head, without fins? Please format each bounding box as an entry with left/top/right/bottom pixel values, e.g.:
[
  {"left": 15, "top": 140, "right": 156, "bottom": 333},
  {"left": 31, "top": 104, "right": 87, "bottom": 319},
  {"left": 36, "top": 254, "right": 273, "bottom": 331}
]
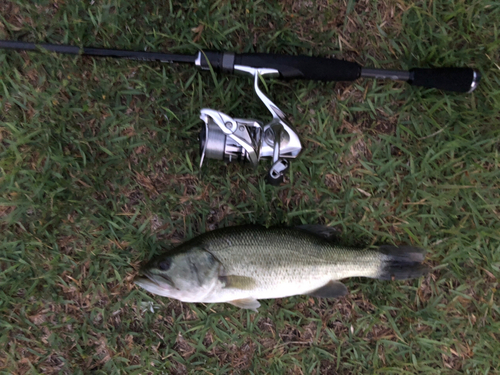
[{"left": 186, "top": 226, "right": 384, "bottom": 298}]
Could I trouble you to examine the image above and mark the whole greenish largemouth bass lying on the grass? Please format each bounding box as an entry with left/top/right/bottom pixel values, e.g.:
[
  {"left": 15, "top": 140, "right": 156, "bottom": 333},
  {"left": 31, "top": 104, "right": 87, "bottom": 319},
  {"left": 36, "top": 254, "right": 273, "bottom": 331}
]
[{"left": 134, "top": 225, "right": 429, "bottom": 311}]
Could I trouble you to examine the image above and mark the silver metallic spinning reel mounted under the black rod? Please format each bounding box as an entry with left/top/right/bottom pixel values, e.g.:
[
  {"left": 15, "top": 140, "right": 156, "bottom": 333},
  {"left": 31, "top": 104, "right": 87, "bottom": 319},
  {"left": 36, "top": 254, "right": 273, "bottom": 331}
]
[{"left": 200, "top": 65, "right": 302, "bottom": 185}]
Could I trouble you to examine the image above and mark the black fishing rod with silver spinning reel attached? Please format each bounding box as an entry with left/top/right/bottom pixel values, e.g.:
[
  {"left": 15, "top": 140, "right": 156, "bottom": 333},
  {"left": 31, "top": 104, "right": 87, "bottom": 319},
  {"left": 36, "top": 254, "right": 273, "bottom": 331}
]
[{"left": 0, "top": 40, "right": 481, "bottom": 185}]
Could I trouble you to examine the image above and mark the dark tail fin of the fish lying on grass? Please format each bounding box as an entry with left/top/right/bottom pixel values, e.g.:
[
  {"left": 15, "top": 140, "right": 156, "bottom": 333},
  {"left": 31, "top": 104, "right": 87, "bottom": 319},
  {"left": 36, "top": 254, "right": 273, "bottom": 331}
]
[{"left": 378, "top": 245, "right": 429, "bottom": 280}]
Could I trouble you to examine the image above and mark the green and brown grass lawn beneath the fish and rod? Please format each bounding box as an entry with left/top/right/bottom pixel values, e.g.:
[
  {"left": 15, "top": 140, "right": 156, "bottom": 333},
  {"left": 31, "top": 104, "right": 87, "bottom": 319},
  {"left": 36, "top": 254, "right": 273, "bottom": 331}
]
[{"left": 0, "top": 0, "right": 500, "bottom": 374}]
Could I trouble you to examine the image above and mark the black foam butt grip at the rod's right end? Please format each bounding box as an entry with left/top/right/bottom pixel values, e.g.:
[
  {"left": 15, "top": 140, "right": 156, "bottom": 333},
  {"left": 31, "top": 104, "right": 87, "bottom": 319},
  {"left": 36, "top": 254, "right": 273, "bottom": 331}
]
[{"left": 408, "top": 68, "right": 481, "bottom": 93}]
